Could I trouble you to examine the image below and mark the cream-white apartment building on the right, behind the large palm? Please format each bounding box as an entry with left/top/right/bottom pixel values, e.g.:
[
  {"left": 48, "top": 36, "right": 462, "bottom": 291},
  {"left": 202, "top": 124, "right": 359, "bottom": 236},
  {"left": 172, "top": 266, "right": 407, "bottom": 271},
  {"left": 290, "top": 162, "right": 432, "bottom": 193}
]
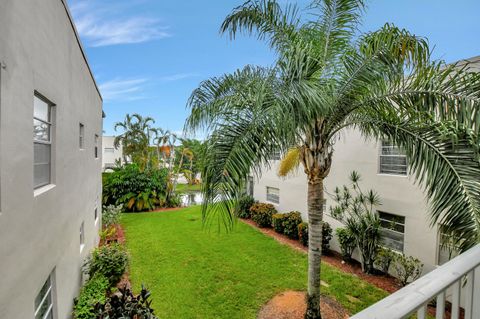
[{"left": 250, "top": 56, "right": 480, "bottom": 272}]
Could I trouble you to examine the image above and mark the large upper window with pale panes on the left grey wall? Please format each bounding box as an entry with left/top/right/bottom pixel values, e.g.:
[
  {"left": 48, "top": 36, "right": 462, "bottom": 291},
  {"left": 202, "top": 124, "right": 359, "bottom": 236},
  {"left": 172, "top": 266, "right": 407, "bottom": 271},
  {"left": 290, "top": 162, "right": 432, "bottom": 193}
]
[{"left": 33, "top": 95, "right": 52, "bottom": 188}]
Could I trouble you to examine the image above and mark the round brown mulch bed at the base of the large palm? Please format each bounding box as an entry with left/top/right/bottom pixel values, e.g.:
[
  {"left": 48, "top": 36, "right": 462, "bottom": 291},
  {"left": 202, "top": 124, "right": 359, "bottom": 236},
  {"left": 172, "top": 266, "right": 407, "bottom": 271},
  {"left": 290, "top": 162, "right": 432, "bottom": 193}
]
[{"left": 257, "top": 291, "right": 348, "bottom": 319}]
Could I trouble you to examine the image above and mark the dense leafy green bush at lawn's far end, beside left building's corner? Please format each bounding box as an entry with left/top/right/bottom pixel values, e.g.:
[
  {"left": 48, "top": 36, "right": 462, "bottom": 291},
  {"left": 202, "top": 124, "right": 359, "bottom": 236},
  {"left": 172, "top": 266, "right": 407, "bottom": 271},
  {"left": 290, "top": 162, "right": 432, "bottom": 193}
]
[{"left": 102, "top": 164, "right": 168, "bottom": 211}]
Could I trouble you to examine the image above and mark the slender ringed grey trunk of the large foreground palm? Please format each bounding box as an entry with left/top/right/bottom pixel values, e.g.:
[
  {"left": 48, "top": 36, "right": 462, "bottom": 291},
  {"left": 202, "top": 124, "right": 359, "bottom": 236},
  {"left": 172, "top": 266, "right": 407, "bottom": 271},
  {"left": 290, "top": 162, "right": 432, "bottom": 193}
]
[{"left": 305, "top": 177, "right": 324, "bottom": 319}]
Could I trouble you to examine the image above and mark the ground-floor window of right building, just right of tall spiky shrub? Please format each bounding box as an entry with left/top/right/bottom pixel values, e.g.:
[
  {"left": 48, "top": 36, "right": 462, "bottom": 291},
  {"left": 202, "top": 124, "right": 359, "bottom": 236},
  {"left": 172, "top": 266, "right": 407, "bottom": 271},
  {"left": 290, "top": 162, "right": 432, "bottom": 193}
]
[{"left": 378, "top": 212, "right": 405, "bottom": 252}]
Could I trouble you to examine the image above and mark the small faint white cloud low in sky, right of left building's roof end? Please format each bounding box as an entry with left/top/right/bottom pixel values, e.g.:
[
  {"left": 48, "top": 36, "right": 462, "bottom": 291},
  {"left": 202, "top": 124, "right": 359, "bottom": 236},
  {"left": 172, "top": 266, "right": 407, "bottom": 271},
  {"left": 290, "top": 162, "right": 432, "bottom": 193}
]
[{"left": 99, "top": 78, "right": 147, "bottom": 101}]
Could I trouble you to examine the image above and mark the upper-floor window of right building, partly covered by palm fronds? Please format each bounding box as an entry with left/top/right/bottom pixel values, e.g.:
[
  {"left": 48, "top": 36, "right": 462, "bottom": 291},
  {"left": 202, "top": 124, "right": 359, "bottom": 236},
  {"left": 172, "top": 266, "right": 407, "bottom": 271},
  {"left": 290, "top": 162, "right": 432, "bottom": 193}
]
[{"left": 380, "top": 141, "right": 407, "bottom": 176}]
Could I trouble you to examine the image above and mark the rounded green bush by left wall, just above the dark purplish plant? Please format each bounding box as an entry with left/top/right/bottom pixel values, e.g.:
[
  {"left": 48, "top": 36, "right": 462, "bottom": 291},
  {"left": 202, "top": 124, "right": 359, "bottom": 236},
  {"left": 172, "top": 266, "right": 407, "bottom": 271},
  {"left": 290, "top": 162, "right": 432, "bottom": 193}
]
[{"left": 84, "top": 243, "right": 128, "bottom": 286}]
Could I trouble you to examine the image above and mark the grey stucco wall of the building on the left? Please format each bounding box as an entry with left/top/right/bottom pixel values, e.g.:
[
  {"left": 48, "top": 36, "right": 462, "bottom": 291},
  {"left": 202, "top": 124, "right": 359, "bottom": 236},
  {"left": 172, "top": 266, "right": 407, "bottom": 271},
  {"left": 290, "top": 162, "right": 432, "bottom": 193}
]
[{"left": 0, "top": 0, "right": 102, "bottom": 319}]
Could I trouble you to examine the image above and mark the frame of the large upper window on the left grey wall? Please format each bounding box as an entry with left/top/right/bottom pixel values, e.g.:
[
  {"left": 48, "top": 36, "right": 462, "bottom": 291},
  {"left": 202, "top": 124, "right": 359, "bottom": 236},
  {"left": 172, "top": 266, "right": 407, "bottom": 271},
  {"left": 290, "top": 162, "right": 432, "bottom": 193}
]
[{"left": 33, "top": 95, "right": 55, "bottom": 190}]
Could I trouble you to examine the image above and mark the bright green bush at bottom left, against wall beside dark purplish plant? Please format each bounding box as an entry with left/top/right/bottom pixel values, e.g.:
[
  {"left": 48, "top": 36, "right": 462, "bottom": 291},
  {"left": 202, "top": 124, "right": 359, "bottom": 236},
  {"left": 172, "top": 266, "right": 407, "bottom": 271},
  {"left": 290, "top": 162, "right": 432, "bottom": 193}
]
[{"left": 73, "top": 274, "right": 110, "bottom": 319}]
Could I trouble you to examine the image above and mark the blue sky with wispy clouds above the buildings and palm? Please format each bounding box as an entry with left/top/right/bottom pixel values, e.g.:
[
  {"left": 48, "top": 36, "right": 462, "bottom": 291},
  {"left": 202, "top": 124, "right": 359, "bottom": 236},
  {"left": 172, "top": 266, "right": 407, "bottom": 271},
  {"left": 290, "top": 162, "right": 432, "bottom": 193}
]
[{"left": 69, "top": 0, "right": 480, "bottom": 135}]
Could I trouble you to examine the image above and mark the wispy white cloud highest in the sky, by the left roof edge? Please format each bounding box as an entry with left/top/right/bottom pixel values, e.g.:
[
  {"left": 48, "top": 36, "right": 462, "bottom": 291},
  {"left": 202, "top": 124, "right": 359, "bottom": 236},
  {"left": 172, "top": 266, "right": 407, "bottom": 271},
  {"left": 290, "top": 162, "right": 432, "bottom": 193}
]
[{"left": 71, "top": 0, "right": 170, "bottom": 47}]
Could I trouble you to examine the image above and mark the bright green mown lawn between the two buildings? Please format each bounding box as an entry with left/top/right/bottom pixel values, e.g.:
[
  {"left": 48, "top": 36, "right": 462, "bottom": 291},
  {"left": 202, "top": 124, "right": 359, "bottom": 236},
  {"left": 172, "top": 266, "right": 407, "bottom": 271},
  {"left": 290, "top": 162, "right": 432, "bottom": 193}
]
[{"left": 122, "top": 207, "right": 387, "bottom": 319}]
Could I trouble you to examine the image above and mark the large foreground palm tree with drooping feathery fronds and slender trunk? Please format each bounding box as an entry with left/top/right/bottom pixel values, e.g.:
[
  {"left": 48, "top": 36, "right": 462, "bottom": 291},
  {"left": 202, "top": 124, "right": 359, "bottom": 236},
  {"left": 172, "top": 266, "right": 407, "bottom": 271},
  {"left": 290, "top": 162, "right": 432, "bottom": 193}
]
[{"left": 186, "top": 0, "right": 480, "bottom": 318}]
